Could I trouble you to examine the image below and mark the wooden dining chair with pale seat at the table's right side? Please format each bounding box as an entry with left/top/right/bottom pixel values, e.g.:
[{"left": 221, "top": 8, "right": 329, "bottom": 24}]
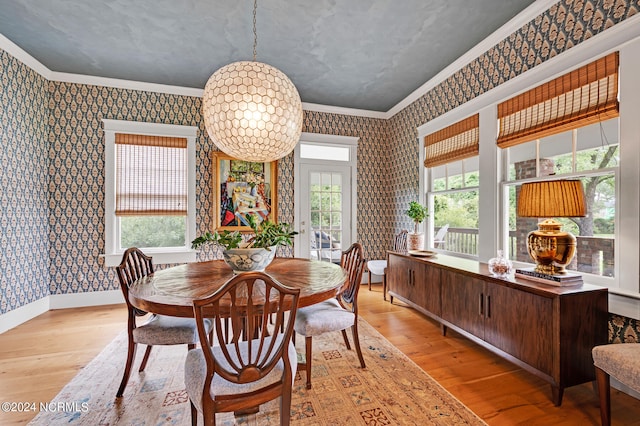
[{"left": 294, "top": 243, "right": 365, "bottom": 389}]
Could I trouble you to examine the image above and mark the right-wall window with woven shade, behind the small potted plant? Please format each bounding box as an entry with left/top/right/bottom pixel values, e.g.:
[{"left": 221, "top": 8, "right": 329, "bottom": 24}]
[{"left": 425, "top": 114, "right": 480, "bottom": 256}]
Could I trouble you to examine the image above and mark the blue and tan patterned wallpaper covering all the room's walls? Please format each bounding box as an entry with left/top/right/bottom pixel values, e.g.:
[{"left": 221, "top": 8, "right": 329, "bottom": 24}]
[{"left": 0, "top": 0, "right": 640, "bottom": 344}]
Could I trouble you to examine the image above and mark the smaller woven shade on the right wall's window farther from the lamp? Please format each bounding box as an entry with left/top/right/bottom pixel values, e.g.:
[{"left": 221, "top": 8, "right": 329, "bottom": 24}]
[{"left": 424, "top": 114, "right": 480, "bottom": 167}]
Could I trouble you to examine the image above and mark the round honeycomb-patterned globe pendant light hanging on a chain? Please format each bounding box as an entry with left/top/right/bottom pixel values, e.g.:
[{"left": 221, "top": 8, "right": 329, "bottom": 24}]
[{"left": 202, "top": 0, "right": 302, "bottom": 162}]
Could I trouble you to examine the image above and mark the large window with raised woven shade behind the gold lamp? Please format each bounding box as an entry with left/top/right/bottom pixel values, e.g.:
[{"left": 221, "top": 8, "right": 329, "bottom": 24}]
[{"left": 497, "top": 52, "right": 620, "bottom": 282}]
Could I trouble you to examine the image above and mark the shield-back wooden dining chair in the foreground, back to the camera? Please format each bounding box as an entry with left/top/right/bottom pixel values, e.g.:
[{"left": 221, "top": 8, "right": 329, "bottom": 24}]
[{"left": 185, "top": 272, "right": 300, "bottom": 426}]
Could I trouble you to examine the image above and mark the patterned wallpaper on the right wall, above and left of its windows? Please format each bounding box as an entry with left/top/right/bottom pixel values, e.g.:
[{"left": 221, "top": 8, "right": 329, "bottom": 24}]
[{"left": 389, "top": 0, "right": 640, "bottom": 232}]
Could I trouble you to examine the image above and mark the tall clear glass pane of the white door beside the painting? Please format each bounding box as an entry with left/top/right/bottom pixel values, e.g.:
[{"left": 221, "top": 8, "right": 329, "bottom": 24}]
[{"left": 309, "top": 172, "right": 343, "bottom": 263}]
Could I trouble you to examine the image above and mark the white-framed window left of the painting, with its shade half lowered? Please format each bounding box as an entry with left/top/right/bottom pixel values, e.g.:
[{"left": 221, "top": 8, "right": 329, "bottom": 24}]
[{"left": 104, "top": 120, "right": 197, "bottom": 266}]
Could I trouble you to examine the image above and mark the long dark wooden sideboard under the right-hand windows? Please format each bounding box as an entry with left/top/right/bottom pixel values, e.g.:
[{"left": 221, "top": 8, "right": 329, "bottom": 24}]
[{"left": 386, "top": 252, "right": 608, "bottom": 406}]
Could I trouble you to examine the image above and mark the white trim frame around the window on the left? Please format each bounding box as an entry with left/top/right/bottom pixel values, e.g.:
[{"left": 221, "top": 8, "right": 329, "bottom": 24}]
[{"left": 102, "top": 119, "right": 198, "bottom": 266}]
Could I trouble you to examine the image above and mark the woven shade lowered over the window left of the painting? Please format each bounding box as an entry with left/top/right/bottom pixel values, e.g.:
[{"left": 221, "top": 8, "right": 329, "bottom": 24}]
[{"left": 115, "top": 133, "right": 187, "bottom": 216}]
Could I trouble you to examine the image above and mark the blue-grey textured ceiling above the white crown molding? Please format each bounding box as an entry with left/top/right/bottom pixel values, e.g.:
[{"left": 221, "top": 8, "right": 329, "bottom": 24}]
[{"left": 0, "top": 0, "right": 533, "bottom": 111}]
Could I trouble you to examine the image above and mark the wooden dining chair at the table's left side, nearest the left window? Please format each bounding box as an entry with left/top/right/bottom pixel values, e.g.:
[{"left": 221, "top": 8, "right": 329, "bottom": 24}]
[{"left": 116, "top": 247, "right": 211, "bottom": 398}]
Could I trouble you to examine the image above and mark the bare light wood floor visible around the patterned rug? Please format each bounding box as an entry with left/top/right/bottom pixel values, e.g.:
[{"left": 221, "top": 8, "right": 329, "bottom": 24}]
[{"left": 0, "top": 285, "right": 640, "bottom": 425}]
